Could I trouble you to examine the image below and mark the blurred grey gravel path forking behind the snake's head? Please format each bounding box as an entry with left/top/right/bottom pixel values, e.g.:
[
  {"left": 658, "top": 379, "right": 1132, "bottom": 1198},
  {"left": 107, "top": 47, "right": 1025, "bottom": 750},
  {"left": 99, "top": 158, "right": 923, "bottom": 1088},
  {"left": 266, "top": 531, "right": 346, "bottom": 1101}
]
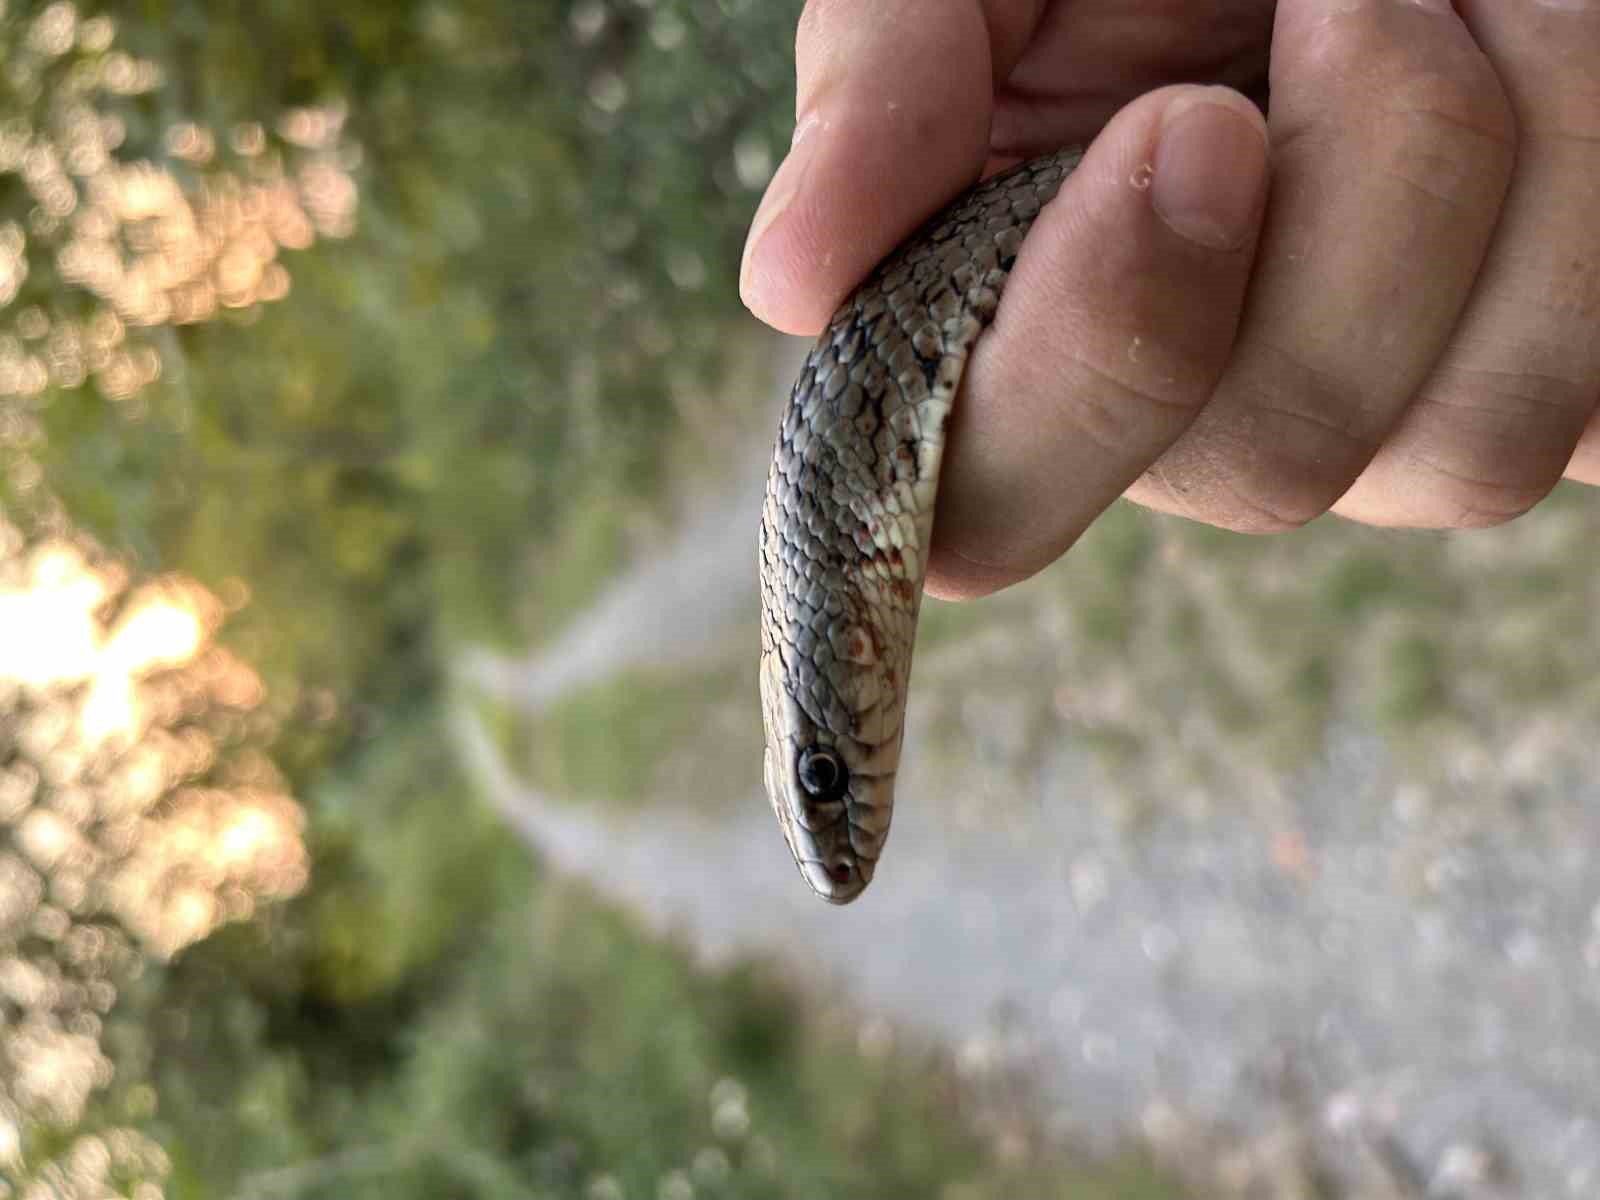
[{"left": 461, "top": 340, "right": 1600, "bottom": 1200}]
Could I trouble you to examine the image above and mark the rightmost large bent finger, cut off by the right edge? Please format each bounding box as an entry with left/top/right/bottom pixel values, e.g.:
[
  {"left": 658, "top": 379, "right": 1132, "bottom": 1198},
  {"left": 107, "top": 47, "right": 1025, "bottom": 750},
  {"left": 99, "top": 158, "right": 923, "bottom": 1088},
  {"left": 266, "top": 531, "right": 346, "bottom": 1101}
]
[{"left": 1334, "top": 0, "right": 1600, "bottom": 528}]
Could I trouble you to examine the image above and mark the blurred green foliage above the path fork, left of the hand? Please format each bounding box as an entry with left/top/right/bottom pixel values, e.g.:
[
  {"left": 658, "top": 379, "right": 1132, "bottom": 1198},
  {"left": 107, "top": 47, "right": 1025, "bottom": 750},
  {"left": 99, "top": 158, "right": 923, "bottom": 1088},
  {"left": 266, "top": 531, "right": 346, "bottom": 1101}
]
[{"left": 26, "top": 0, "right": 812, "bottom": 730}]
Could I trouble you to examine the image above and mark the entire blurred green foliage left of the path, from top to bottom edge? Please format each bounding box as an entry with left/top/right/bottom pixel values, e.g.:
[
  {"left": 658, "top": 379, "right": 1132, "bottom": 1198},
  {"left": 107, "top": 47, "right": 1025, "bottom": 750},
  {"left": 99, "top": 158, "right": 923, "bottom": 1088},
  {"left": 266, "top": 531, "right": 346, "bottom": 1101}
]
[{"left": 0, "top": 0, "right": 1160, "bottom": 1200}]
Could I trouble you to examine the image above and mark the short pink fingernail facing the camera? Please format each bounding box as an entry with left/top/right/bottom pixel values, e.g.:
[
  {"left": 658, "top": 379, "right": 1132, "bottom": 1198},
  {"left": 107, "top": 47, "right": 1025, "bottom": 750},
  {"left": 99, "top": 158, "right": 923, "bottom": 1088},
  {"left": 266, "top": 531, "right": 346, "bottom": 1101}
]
[{"left": 1150, "top": 91, "right": 1267, "bottom": 250}]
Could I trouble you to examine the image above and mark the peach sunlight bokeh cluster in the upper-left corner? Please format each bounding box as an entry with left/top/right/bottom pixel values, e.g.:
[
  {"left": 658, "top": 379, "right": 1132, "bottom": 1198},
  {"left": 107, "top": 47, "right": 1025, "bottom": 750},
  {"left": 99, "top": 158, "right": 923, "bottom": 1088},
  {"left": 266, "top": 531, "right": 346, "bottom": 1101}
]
[{"left": 0, "top": 0, "right": 358, "bottom": 422}]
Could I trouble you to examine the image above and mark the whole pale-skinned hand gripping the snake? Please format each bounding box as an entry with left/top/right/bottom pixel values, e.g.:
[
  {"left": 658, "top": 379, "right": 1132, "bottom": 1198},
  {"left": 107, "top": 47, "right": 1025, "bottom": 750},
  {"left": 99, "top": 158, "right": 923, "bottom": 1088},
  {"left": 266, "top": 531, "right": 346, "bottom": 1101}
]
[{"left": 741, "top": 0, "right": 1600, "bottom": 598}]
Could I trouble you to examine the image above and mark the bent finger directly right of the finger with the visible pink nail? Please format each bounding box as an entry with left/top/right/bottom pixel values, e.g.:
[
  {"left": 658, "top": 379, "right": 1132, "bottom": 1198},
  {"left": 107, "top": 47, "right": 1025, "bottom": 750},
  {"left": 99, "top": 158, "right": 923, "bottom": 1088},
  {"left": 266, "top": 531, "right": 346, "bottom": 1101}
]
[{"left": 1128, "top": 0, "right": 1515, "bottom": 533}]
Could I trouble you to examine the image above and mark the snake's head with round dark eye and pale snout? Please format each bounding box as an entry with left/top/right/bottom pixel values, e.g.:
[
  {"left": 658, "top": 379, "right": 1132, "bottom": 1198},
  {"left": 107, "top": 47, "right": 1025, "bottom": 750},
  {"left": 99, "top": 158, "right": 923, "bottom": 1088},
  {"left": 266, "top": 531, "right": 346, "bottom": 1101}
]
[{"left": 762, "top": 653, "right": 899, "bottom": 904}]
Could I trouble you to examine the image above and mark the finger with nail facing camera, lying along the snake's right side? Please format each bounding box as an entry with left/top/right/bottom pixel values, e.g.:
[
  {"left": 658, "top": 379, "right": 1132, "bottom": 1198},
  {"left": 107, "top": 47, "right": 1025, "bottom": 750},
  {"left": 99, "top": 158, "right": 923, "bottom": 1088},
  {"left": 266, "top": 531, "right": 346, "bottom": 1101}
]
[{"left": 926, "top": 86, "right": 1267, "bottom": 598}]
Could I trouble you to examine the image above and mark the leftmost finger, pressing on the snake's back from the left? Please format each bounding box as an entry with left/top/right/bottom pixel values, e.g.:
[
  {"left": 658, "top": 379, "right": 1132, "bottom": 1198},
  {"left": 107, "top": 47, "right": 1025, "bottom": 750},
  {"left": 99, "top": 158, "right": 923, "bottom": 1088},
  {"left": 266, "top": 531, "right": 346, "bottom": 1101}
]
[{"left": 739, "top": 0, "right": 1043, "bottom": 334}]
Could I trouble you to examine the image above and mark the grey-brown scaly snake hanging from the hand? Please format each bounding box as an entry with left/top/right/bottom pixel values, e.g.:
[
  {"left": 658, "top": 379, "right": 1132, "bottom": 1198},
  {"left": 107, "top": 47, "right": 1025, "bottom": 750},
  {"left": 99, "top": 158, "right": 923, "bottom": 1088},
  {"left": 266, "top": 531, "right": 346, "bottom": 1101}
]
[{"left": 760, "top": 149, "right": 1082, "bottom": 904}]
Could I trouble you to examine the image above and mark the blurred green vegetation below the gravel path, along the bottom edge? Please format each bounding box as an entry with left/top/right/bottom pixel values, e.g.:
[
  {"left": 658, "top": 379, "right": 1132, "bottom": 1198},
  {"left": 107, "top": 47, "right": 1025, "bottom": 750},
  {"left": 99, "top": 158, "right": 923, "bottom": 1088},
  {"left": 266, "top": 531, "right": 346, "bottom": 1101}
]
[{"left": 162, "top": 700, "right": 1179, "bottom": 1200}]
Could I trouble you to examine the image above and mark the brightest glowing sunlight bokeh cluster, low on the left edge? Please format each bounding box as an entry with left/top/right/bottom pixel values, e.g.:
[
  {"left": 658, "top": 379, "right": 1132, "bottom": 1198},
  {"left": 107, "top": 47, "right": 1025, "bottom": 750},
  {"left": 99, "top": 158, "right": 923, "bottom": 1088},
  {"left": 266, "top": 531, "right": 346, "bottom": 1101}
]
[{"left": 0, "top": 522, "right": 307, "bottom": 1200}]
